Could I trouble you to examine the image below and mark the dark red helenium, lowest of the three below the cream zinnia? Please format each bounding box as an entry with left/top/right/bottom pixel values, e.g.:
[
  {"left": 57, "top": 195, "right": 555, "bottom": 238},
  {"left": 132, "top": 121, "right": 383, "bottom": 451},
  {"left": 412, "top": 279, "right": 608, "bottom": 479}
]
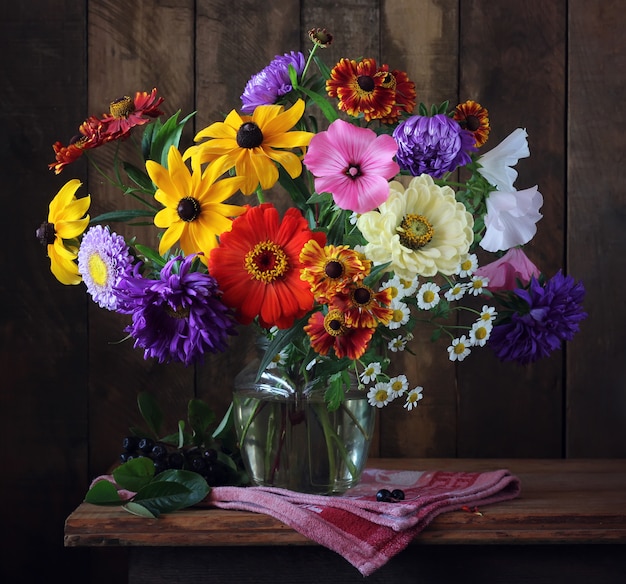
[{"left": 304, "top": 309, "right": 374, "bottom": 361}]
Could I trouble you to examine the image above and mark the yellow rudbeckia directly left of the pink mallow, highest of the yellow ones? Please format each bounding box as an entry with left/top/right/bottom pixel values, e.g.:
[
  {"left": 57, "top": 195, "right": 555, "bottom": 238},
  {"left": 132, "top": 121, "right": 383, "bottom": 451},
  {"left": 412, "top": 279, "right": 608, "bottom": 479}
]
[{"left": 185, "top": 99, "right": 314, "bottom": 195}]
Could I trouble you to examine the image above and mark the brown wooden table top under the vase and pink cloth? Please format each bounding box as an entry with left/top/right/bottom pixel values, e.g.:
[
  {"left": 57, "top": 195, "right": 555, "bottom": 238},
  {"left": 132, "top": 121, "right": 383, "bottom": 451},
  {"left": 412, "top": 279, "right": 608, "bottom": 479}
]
[{"left": 65, "top": 459, "right": 626, "bottom": 547}]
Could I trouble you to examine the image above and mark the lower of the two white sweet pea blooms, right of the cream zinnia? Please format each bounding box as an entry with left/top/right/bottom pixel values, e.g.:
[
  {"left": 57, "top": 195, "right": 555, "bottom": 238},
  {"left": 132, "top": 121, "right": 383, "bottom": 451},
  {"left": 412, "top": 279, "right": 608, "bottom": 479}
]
[{"left": 480, "top": 186, "right": 543, "bottom": 252}]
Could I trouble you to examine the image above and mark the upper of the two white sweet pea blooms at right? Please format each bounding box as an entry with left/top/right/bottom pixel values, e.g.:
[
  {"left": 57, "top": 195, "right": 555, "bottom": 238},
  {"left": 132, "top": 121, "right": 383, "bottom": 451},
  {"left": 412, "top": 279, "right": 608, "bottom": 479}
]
[{"left": 478, "top": 128, "right": 530, "bottom": 191}]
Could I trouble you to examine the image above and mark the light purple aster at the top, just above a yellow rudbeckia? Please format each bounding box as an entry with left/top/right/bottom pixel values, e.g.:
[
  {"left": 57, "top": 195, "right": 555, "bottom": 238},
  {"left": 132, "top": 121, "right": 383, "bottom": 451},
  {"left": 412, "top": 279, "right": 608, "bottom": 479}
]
[{"left": 241, "top": 51, "right": 305, "bottom": 114}]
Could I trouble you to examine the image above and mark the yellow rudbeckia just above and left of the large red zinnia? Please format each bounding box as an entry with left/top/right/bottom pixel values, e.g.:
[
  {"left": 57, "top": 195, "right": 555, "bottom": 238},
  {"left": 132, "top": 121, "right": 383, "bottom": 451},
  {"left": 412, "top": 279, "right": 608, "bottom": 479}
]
[{"left": 146, "top": 146, "right": 245, "bottom": 263}]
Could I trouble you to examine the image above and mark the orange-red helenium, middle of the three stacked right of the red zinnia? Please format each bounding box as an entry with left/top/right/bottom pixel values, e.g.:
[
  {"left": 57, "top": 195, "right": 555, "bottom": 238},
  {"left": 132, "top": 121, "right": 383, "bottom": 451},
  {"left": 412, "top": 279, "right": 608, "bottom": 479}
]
[{"left": 332, "top": 282, "right": 393, "bottom": 328}]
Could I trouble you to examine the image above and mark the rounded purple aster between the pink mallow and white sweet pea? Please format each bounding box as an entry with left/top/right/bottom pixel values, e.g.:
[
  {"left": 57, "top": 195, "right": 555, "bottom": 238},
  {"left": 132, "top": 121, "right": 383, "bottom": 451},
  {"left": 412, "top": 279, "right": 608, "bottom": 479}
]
[{"left": 393, "top": 114, "right": 476, "bottom": 178}]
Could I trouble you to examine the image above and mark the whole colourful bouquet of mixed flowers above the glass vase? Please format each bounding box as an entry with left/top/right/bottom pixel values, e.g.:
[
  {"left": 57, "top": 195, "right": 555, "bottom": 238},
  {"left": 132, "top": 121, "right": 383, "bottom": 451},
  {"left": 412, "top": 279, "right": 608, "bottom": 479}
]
[{"left": 37, "top": 28, "right": 586, "bottom": 498}]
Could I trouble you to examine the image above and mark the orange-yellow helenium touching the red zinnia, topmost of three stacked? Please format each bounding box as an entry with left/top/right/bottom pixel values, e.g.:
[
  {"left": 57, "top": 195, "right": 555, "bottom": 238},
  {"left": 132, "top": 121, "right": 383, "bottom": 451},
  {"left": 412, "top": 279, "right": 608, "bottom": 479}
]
[{"left": 300, "top": 239, "right": 372, "bottom": 304}]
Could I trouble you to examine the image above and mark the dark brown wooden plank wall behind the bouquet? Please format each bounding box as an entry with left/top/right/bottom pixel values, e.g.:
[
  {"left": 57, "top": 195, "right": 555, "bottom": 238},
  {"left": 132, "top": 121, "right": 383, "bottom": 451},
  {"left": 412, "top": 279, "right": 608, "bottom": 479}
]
[{"left": 0, "top": 0, "right": 626, "bottom": 583}]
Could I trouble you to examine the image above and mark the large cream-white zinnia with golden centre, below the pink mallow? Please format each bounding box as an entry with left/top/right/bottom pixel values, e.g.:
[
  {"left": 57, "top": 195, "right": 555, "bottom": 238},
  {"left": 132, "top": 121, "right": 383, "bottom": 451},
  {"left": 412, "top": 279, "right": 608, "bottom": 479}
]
[{"left": 357, "top": 174, "right": 474, "bottom": 280}]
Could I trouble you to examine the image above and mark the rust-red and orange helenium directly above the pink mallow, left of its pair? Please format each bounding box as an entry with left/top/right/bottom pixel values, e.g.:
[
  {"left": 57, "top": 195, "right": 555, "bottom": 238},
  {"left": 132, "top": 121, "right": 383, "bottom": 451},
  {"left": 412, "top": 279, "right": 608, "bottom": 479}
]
[{"left": 326, "top": 59, "right": 395, "bottom": 122}]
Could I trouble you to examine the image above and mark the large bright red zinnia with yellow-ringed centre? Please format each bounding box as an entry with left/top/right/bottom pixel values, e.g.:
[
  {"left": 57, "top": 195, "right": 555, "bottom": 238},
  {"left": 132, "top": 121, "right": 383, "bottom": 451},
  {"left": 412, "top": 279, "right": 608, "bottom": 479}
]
[{"left": 209, "top": 203, "right": 325, "bottom": 329}]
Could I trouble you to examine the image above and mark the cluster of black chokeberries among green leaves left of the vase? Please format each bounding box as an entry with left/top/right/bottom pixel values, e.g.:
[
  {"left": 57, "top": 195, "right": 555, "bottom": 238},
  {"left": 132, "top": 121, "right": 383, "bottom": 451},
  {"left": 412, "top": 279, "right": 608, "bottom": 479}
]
[{"left": 120, "top": 436, "right": 230, "bottom": 487}]
